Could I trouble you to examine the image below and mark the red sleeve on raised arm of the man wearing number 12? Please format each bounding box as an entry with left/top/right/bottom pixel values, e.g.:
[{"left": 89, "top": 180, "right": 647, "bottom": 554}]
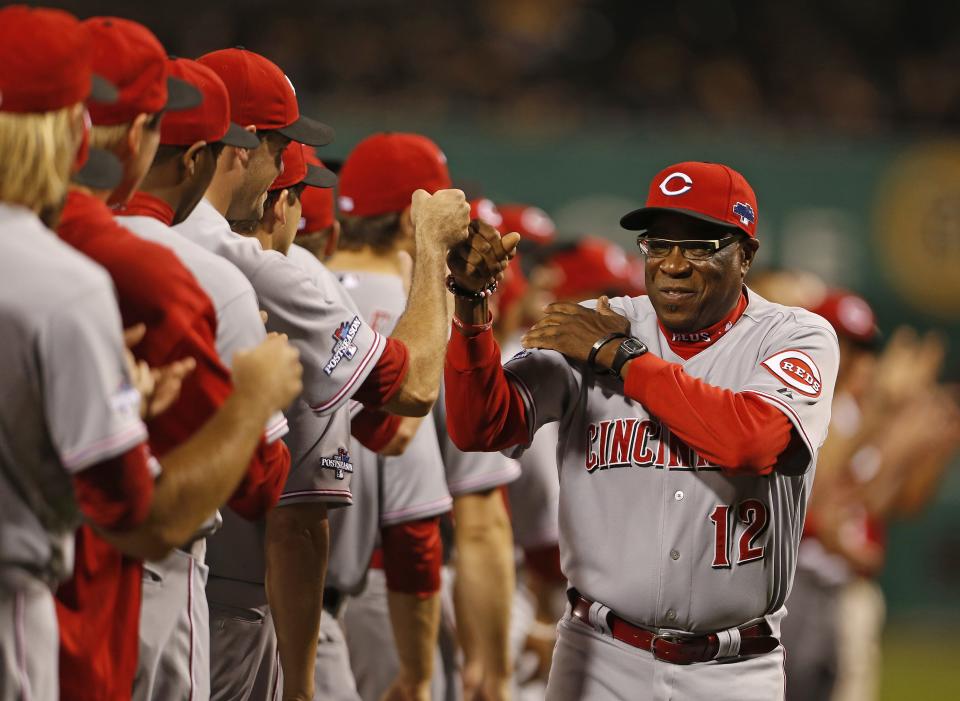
[{"left": 443, "top": 328, "right": 530, "bottom": 451}]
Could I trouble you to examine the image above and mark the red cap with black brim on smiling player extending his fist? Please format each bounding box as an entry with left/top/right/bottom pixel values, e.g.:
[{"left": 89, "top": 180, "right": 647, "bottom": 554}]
[{"left": 197, "top": 48, "right": 333, "bottom": 146}]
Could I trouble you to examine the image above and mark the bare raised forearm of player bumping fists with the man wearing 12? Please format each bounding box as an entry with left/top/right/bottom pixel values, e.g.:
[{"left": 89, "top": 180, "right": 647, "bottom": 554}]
[{"left": 385, "top": 243, "right": 450, "bottom": 416}]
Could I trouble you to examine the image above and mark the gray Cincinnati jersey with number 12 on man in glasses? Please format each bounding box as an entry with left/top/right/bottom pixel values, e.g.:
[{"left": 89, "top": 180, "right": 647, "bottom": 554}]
[{"left": 505, "top": 291, "right": 839, "bottom": 632}]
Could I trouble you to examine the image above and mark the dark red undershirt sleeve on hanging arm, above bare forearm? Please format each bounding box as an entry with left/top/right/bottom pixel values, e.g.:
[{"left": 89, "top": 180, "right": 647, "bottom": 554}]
[{"left": 380, "top": 516, "right": 443, "bottom": 599}]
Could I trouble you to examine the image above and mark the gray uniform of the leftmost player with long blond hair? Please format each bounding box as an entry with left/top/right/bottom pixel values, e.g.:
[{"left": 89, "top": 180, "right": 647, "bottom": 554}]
[{"left": 0, "top": 204, "right": 148, "bottom": 701}]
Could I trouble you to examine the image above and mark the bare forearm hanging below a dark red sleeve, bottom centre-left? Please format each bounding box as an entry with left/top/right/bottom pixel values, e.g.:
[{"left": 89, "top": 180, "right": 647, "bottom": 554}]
[{"left": 387, "top": 591, "right": 440, "bottom": 701}]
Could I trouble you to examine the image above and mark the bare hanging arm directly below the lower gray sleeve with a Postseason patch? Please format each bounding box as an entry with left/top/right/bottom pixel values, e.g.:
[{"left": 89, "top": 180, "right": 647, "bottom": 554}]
[{"left": 264, "top": 503, "right": 330, "bottom": 700}]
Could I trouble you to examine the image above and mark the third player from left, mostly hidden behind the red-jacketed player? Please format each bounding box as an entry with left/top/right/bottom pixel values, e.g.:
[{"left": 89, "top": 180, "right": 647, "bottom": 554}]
[{"left": 117, "top": 58, "right": 289, "bottom": 701}]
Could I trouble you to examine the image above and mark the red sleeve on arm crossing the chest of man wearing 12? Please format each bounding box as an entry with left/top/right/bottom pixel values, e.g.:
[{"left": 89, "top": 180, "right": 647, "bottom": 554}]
[{"left": 624, "top": 353, "right": 793, "bottom": 475}]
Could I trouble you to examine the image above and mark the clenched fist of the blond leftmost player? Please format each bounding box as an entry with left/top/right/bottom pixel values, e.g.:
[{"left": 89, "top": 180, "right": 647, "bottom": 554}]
[{"left": 233, "top": 334, "right": 303, "bottom": 412}]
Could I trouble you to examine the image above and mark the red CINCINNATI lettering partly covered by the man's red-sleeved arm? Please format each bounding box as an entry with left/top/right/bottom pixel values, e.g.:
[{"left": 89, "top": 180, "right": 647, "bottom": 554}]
[{"left": 584, "top": 418, "right": 720, "bottom": 473}]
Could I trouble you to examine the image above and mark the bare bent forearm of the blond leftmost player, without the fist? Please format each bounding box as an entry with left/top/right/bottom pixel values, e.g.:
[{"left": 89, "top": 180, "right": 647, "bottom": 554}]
[{"left": 105, "top": 391, "right": 270, "bottom": 559}]
